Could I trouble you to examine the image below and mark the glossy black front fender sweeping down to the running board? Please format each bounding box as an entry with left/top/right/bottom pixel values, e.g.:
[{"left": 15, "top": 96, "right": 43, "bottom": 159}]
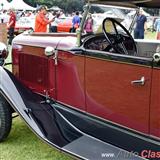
[{"left": 0, "top": 67, "right": 82, "bottom": 148}]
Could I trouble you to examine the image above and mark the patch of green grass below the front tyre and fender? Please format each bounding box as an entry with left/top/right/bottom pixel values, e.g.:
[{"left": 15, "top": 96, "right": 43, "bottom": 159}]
[{"left": 0, "top": 118, "right": 73, "bottom": 160}]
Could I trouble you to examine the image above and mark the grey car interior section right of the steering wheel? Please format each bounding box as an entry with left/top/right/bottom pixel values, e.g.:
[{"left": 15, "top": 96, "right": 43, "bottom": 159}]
[{"left": 135, "top": 39, "right": 160, "bottom": 57}]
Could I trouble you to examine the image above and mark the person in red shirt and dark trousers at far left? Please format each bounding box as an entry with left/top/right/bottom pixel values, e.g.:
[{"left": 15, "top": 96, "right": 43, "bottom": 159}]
[{"left": 8, "top": 8, "right": 16, "bottom": 45}]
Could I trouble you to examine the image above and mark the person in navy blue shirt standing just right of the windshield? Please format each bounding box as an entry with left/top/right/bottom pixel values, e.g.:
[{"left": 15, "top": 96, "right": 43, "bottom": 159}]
[{"left": 134, "top": 9, "right": 147, "bottom": 39}]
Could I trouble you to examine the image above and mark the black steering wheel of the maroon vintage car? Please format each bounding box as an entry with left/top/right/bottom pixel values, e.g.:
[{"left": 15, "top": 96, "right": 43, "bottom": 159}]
[{"left": 102, "top": 17, "right": 137, "bottom": 55}]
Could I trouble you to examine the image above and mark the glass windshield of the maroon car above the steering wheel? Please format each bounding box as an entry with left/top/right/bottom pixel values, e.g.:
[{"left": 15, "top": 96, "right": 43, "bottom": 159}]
[{"left": 89, "top": 4, "right": 136, "bottom": 33}]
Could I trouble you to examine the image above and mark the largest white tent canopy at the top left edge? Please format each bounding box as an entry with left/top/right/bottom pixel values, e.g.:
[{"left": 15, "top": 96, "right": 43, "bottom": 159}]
[{"left": 9, "top": 0, "right": 35, "bottom": 10}]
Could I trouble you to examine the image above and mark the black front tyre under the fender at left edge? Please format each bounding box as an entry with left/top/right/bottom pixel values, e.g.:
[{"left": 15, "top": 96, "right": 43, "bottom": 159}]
[{"left": 0, "top": 95, "right": 12, "bottom": 142}]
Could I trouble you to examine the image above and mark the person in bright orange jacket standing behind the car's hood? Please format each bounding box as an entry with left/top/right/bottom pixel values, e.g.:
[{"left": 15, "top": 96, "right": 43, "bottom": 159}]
[{"left": 34, "top": 6, "right": 54, "bottom": 32}]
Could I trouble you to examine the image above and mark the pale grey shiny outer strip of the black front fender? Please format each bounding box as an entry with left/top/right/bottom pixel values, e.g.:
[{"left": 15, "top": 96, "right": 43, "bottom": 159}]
[{"left": 0, "top": 67, "right": 45, "bottom": 141}]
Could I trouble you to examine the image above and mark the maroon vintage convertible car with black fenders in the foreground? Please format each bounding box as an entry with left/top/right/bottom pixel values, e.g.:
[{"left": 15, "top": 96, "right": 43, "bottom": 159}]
[{"left": 0, "top": 0, "right": 160, "bottom": 160}]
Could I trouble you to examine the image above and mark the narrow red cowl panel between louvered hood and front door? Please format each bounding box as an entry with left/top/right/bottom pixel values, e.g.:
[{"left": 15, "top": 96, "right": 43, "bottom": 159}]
[{"left": 56, "top": 51, "right": 85, "bottom": 111}]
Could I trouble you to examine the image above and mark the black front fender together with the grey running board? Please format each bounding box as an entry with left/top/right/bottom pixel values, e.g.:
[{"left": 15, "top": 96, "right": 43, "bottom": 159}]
[{"left": 0, "top": 67, "right": 146, "bottom": 160}]
